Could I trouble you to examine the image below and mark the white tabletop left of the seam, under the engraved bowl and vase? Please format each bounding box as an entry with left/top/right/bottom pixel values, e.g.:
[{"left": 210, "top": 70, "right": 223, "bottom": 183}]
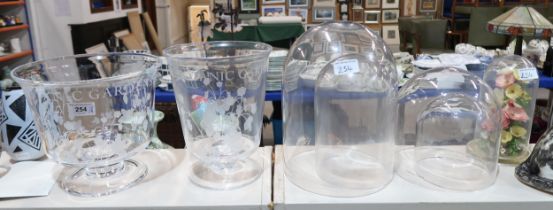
[{"left": 0, "top": 147, "right": 272, "bottom": 210}]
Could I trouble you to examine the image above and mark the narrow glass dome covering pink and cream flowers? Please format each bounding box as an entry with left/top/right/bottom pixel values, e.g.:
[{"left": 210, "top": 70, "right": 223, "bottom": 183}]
[{"left": 484, "top": 55, "right": 539, "bottom": 163}]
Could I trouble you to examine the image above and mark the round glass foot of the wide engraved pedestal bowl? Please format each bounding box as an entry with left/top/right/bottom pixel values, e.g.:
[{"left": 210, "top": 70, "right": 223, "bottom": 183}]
[{"left": 60, "top": 160, "right": 148, "bottom": 197}]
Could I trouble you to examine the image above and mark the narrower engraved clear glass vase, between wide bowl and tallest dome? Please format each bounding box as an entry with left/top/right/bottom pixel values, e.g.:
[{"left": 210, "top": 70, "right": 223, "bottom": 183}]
[{"left": 164, "top": 41, "right": 272, "bottom": 189}]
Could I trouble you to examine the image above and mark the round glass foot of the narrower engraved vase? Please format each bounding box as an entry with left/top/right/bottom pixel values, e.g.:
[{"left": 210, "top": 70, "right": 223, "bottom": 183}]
[{"left": 190, "top": 159, "right": 263, "bottom": 190}]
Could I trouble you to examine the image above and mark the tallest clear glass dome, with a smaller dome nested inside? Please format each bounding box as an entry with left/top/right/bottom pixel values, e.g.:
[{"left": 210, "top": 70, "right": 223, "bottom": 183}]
[{"left": 283, "top": 22, "right": 398, "bottom": 196}]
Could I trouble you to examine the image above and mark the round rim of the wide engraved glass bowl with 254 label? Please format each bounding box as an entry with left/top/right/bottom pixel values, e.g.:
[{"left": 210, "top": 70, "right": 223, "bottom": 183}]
[{"left": 10, "top": 52, "right": 161, "bottom": 88}]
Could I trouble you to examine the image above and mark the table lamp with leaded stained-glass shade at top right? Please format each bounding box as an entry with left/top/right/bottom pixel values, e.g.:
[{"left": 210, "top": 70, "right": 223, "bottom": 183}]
[{"left": 488, "top": 6, "right": 553, "bottom": 55}]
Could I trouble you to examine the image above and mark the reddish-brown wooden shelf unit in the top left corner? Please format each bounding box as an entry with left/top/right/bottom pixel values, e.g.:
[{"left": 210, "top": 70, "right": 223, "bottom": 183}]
[{"left": 0, "top": 0, "right": 33, "bottom": 71}]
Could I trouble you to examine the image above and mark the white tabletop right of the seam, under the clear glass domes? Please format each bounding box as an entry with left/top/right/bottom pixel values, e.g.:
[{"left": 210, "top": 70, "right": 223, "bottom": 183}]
[{"left": 273, "top": 145, "right": 553, "bottom": 210}]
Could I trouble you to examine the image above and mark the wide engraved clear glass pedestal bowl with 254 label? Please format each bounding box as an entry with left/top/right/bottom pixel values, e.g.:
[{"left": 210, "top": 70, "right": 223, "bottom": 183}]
[{"left": 12, "top": 53, "right": 159, "bottom": 197}]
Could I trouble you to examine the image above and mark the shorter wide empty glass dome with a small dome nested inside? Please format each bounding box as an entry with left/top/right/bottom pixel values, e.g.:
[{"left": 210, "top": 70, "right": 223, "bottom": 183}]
[{"left": 398, "top": 67, "right": 501, "bottom": 191}]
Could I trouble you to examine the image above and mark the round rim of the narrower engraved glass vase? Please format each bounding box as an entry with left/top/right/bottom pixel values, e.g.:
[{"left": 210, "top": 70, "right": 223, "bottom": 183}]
[{"left": 163, "top": 40, "right": 273, "bottom": 61}]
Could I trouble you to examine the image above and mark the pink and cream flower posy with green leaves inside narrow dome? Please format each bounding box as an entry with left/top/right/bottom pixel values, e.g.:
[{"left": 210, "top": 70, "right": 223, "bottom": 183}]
[{"left": 495, "top": 68, "right": 532, "bottom": 157}]
